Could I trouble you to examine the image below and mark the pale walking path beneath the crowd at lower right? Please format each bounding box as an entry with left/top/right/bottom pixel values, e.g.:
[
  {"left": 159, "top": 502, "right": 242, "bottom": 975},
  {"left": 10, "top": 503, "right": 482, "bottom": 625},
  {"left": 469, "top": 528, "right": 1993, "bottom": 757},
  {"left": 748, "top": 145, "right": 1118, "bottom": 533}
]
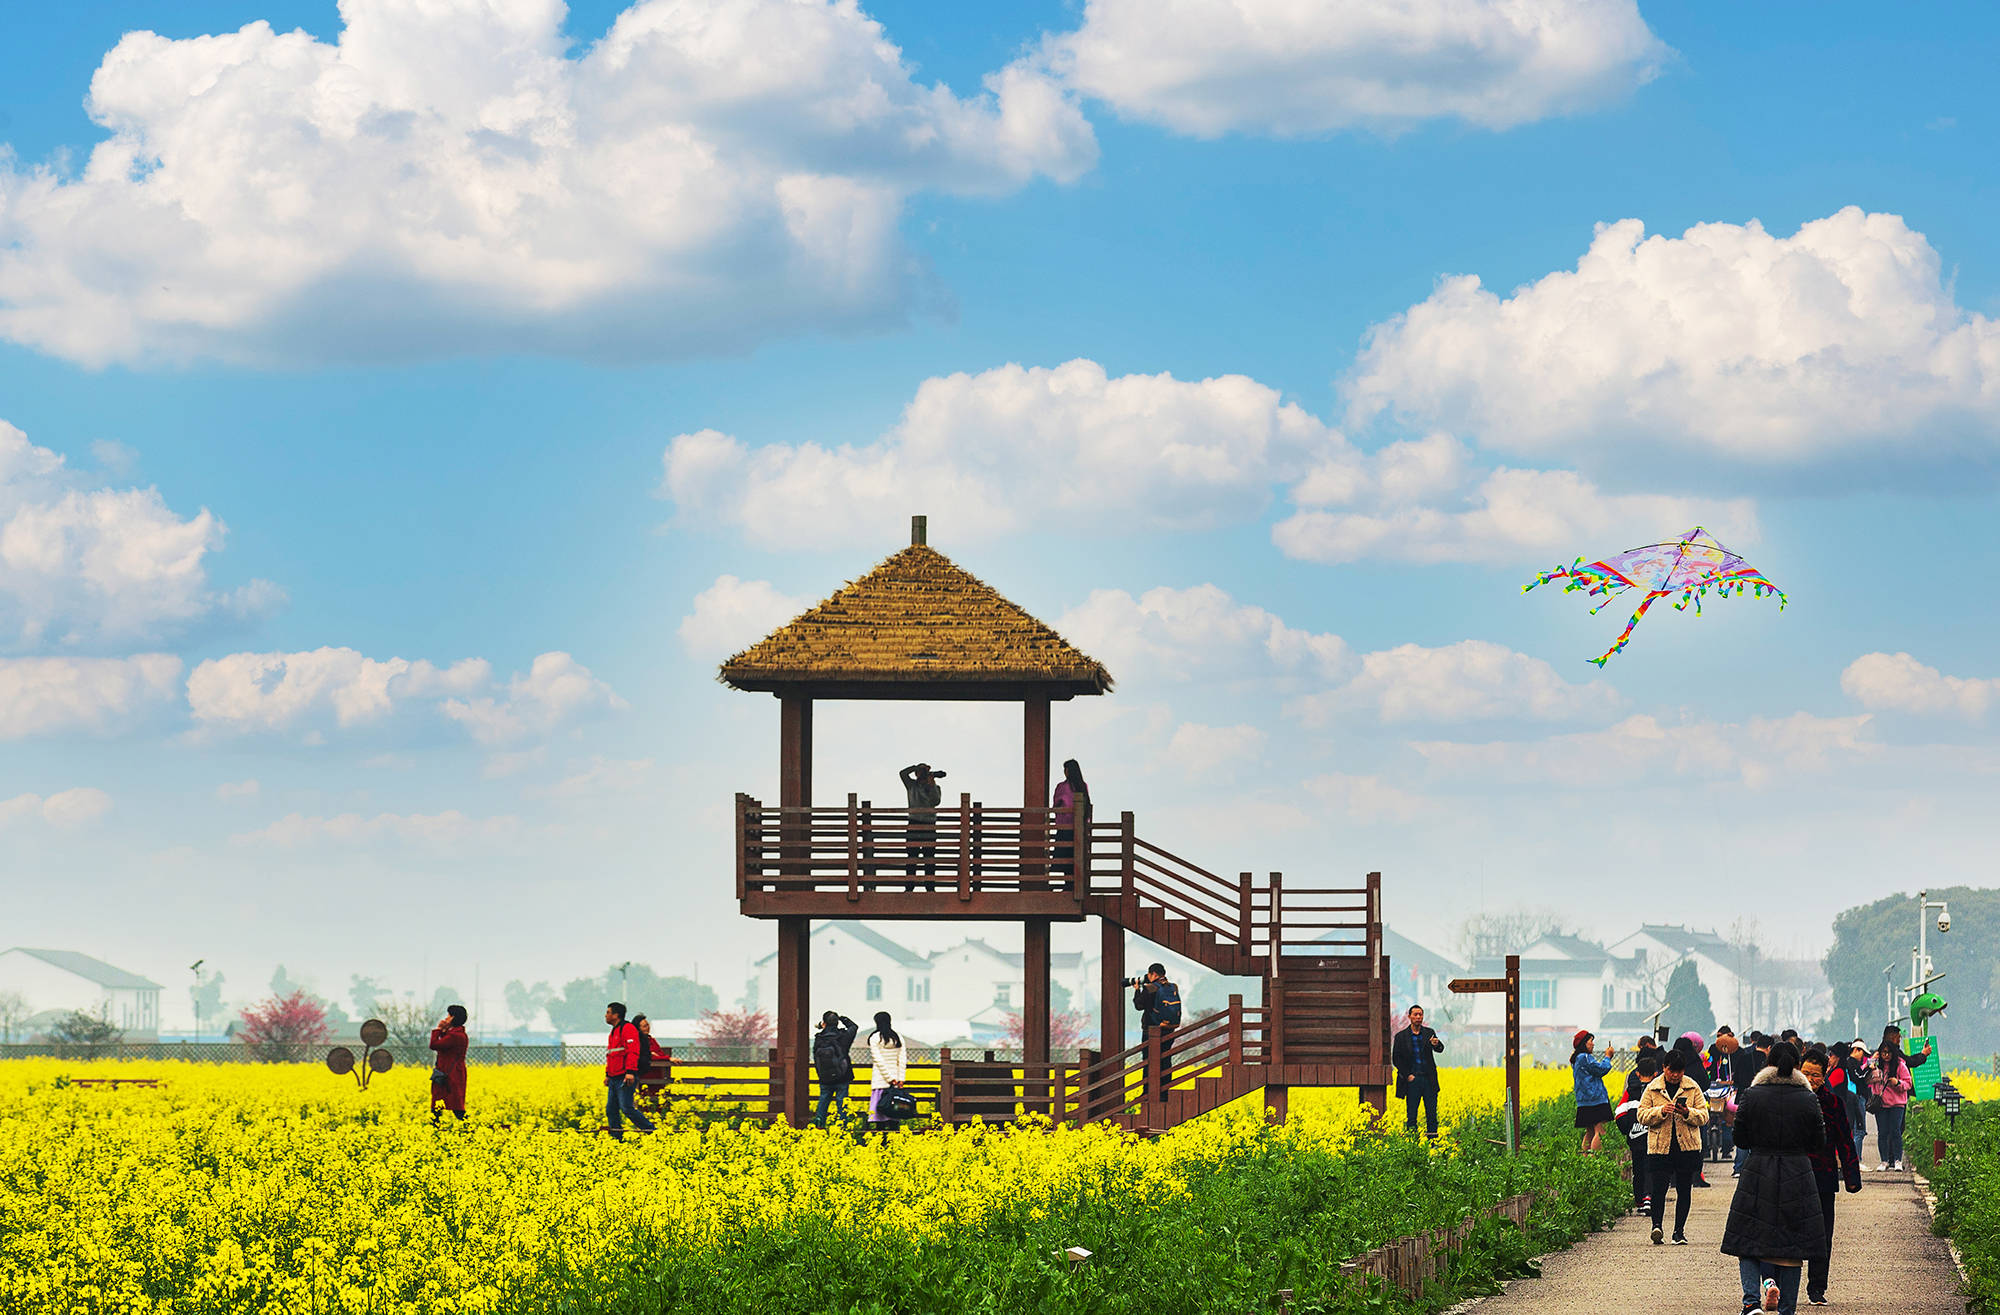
[{"left": 1462, "top": 1137, "right": 1964, "bottom": 1315}]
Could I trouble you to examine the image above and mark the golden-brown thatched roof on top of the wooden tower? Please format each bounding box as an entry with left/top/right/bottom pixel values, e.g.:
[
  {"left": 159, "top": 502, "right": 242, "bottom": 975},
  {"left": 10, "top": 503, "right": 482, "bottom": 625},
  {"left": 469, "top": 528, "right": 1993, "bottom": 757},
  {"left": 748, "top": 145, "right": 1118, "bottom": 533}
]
[{"left": 720, "top": 544, "right": 1112, "bottom": 699}]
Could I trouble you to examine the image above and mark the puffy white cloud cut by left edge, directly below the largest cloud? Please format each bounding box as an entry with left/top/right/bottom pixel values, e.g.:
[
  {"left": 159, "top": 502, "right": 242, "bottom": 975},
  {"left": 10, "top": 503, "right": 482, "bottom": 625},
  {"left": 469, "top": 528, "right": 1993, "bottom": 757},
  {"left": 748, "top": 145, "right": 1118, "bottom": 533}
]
[{"left": 0, "top": 417, "right": 284, "bottom": 648}]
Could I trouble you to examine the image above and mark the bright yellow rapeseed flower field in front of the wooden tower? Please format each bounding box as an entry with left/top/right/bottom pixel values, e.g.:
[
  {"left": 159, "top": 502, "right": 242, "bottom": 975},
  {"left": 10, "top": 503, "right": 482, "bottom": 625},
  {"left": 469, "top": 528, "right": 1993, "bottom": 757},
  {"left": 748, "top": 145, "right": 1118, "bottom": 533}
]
[{"left": 0, "top": 1059, "right": 1752, "bottom": 1315}]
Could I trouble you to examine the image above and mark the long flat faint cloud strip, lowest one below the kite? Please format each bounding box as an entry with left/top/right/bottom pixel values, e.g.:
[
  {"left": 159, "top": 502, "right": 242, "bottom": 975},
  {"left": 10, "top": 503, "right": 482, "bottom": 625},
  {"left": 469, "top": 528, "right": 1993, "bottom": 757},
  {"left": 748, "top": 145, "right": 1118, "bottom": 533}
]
[{"left": 1410, "top": 713, "right": 1876, "bottom": 789}]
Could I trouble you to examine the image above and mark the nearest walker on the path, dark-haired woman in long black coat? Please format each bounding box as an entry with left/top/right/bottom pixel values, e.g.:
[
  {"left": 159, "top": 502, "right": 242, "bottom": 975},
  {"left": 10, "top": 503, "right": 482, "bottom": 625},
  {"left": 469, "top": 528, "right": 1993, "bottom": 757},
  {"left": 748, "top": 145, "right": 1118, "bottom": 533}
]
[{"left": 1722, "top": 1041, "right": 1826, "bottom": 1315}]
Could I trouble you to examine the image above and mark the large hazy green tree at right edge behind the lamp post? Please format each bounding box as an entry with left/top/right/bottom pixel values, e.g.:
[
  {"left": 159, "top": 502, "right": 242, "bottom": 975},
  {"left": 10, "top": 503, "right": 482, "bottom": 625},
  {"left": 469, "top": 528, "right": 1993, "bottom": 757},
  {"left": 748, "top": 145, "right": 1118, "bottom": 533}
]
[{"left": 1814, "top": 885, "right": 2000, "bottom": 1055}]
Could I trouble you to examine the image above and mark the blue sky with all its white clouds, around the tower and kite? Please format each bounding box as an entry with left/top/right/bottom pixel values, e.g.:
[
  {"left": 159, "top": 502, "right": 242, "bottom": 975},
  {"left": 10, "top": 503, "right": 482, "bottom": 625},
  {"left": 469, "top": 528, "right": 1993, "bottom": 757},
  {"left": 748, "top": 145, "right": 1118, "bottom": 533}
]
[{"left": 0, "top": 0, "right": 2000, "bottom": 1023}]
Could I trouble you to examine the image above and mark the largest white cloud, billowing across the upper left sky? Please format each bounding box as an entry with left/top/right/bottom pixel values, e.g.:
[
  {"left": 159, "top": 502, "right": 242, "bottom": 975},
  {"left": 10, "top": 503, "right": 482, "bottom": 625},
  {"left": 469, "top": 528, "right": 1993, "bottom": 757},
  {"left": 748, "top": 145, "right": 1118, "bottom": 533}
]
[{"left": 0, "top": 0, "right": 1096, "bottom": 364}]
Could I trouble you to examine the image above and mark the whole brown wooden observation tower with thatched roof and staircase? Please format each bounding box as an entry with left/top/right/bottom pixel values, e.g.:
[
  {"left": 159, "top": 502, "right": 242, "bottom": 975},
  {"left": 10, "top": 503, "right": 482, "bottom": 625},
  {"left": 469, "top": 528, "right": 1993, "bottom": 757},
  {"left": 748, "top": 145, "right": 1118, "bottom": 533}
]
[{"left": 720, "top": 516, "right": 1390, "bottom": 1129}]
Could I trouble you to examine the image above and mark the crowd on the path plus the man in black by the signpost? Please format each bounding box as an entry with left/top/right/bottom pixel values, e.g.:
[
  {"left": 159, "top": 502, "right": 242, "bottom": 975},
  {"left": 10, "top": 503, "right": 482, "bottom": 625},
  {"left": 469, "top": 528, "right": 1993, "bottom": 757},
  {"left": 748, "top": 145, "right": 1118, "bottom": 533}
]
[{"left": 1390, "top": 1005, "right": 1932, "bottom": 1315}]
